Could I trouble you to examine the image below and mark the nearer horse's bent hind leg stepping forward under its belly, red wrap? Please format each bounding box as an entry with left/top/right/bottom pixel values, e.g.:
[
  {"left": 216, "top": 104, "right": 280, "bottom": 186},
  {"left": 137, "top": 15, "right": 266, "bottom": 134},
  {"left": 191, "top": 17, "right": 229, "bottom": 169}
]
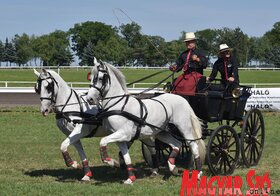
[{"left": 156, "top": 132, "right": 182, "bottom": 175}]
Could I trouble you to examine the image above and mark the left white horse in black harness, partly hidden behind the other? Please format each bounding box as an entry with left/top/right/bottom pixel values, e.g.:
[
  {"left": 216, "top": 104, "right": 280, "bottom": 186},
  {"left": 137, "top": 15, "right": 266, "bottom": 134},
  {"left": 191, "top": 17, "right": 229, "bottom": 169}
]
[{"left": 34, "top": 69, "right": 114, "bottom": 181}]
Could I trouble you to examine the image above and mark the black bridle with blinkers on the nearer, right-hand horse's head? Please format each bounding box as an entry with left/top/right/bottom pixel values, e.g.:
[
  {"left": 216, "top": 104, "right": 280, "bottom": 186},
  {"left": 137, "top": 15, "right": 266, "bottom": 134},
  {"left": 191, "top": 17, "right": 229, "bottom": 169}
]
[{"left": 89, "top": 63, "right": 111, "bottom": 99}]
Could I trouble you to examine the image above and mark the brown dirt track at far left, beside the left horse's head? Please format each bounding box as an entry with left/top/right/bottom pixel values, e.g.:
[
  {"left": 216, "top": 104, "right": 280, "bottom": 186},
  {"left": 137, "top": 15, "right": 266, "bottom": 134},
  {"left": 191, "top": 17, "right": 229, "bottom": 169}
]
[{"left": 0, "top": 93, "right": 40, "bottom": 107}]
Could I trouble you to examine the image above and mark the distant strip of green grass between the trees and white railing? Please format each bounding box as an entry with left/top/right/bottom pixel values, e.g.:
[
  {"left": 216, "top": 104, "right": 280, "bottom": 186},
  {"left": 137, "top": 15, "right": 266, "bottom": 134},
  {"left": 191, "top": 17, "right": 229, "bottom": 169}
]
[{"left": 0, "top": 69, "right": 280, "bottom": 86}]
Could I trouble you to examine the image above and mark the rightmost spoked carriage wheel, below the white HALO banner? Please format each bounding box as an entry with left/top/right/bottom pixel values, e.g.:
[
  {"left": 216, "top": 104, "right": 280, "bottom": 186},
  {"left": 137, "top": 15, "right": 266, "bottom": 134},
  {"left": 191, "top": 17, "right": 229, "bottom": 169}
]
[{"left": 240, "top": 109, "right": 265, "bottom": 167}]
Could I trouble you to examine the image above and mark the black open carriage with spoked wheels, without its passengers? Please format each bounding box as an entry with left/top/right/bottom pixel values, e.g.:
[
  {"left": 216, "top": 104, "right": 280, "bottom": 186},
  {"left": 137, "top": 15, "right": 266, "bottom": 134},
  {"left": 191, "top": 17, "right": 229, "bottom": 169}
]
[{"left": 142, "top": 80, "right": 265, "bottom": 175}]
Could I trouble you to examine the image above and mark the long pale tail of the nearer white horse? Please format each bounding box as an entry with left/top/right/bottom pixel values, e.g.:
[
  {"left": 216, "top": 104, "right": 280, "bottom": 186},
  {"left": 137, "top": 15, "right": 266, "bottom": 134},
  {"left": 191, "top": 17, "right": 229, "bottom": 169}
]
[{"left": 191, "top": 110, "right": 206, "bottom": 164}]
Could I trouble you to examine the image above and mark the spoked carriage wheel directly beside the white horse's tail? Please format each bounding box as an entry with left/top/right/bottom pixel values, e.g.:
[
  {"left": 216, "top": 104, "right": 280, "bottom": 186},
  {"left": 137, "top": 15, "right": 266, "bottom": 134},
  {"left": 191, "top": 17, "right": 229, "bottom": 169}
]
[{"left": 206, "top": 125, "right": 240, "bottom": 175}]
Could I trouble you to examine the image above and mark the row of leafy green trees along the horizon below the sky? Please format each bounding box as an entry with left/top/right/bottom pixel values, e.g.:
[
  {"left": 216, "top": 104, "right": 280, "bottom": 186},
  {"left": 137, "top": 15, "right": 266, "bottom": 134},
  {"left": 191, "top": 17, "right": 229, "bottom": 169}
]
[{"left": 0, "top": 21, "right": 280, "bottom": 67}]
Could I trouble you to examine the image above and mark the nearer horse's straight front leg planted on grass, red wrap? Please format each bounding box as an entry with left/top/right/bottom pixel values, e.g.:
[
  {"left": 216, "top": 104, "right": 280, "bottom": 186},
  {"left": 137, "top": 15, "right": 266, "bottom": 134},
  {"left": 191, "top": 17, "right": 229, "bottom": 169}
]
[{"left": 117, "top": 142, "right": 136, "bottom": 184}]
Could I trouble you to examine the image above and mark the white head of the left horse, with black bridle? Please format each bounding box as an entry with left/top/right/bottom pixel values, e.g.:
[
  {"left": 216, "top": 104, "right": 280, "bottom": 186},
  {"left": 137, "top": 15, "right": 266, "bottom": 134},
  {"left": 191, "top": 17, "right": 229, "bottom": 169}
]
[{"left": 34, "top": 69, "right": 59, "bottom": 116}]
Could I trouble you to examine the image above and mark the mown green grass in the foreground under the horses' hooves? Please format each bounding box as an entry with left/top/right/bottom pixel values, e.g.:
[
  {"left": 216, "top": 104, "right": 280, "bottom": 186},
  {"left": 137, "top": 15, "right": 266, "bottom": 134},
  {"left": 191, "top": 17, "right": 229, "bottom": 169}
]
[{"left": 0, "top": 107, "right": 280, "bottom": 196}]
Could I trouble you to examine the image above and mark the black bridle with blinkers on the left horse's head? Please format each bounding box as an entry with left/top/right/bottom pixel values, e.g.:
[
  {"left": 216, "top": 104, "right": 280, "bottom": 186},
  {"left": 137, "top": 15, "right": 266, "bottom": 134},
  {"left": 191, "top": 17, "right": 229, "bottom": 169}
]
[{"left": 34, "top": 76, "right": 58, "bottom": 104}]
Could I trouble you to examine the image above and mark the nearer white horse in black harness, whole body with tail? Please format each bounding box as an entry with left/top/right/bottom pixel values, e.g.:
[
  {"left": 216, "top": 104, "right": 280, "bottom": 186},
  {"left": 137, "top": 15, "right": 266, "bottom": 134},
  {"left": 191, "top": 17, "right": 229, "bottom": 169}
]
[{"left": 87, "top": 59, "right": 205, "bottom": 184}]
